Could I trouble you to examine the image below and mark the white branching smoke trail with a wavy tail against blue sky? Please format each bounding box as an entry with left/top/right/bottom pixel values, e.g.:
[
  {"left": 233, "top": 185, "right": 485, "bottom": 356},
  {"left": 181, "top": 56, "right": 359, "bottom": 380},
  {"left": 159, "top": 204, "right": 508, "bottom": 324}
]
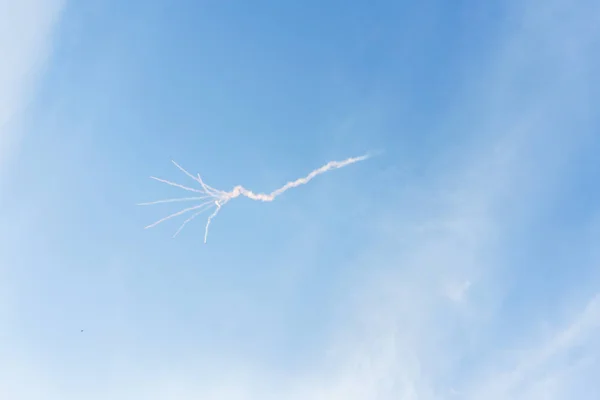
[{"left": 138, "top": 154, "right": 370, "bottom": 243}]
